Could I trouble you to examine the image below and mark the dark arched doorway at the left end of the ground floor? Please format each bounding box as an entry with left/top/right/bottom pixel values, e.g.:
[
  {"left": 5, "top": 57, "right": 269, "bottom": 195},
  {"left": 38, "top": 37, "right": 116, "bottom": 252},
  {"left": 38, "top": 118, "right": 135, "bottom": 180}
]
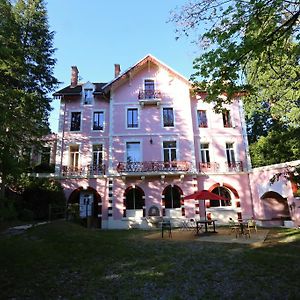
[{"left": 68, "top": 187, "right": 102, "bottom": 228}]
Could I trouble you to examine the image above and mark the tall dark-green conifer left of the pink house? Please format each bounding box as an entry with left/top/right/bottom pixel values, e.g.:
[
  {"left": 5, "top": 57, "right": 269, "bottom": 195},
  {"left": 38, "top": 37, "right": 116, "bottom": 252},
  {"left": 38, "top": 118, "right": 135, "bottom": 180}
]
[{"left": 0, "top": 0, "right": 57, "bottom": 200}]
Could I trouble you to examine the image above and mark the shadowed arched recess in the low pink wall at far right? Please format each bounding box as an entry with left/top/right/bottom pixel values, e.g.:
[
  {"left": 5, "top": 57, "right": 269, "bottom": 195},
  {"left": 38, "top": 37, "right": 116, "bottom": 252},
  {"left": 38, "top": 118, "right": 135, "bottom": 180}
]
[{"left": 260, "top": 191, "right": 291, "bottom": 221}]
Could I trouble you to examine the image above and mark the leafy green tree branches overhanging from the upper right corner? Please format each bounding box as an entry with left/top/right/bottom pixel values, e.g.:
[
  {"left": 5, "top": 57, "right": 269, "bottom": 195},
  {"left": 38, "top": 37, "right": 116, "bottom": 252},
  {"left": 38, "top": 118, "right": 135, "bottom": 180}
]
[{"left": 171, "top": 0, "right": 300, "bottom": 113}]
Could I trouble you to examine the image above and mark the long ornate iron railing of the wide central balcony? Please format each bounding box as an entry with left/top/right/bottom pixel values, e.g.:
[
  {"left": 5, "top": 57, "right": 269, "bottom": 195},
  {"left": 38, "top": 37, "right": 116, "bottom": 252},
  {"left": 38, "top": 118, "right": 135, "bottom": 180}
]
[{"left": 117, "top": 161, "right": 191, "bottom": 173}]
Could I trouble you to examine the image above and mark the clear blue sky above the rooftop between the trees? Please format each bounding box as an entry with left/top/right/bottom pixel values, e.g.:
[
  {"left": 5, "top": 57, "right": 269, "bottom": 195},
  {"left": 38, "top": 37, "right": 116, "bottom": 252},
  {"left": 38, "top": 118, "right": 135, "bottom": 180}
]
[{"left": 47, "top": 0, "right": 199, "bottom": 132}]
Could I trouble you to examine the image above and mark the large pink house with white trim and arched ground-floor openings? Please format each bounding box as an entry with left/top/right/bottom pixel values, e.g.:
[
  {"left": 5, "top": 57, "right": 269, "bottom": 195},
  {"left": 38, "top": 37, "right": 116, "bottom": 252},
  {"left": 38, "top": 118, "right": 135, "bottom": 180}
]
[{"left": 50, "top": 55, "right": 299, "bottom": 228}]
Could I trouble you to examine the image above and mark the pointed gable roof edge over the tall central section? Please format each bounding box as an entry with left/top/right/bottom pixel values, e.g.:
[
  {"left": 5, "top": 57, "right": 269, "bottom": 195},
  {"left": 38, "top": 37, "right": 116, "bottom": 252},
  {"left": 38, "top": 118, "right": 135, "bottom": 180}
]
[{"left": 102, "top": 54, "right": 190, "bottom": 90}]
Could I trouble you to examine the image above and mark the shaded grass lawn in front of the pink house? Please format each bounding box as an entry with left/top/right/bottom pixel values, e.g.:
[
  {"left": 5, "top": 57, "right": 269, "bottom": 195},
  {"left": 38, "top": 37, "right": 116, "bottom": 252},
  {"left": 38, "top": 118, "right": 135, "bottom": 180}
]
[{"left": 0, "top": 221, "right": 300, "bottom": 299}]
